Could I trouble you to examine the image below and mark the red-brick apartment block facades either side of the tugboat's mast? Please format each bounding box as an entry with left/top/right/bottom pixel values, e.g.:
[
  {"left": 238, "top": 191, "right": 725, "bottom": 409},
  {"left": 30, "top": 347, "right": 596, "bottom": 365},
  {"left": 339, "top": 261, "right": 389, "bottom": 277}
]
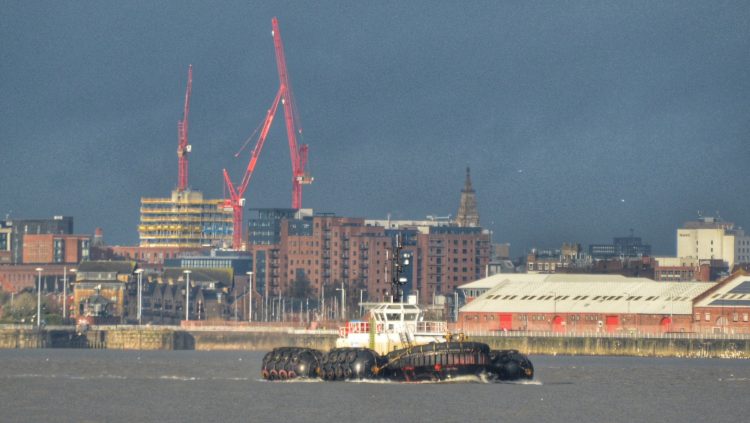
[{"left": 250, "top": 215, "right": 490, "bottom": 302}]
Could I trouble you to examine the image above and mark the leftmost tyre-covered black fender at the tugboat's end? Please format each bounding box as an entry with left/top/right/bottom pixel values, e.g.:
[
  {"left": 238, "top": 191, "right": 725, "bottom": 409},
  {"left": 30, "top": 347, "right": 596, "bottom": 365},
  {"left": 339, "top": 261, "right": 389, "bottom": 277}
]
[{"left": 261, "top": 347, "right": 323, "bottom": 380}]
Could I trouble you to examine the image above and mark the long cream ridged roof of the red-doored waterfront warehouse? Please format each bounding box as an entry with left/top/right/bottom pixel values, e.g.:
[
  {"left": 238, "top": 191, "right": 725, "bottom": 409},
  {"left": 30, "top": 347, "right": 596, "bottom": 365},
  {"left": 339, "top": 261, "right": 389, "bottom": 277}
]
[{"left": 459, "top": 274, "right": 715, "bottom": 314}]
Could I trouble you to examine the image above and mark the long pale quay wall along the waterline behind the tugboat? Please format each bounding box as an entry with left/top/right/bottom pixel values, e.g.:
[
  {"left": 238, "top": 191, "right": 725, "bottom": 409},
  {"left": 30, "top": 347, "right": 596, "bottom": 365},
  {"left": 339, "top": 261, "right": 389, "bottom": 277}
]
[{"left": 0, "top": 326, "right": 750, "bottom": 359}]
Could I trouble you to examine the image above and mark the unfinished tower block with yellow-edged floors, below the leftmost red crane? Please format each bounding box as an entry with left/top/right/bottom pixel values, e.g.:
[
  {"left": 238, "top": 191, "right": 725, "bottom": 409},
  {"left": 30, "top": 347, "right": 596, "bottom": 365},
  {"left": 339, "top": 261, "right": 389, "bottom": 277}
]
[{"left": 138, "top": 189, "right": 233, "bottom": 248}]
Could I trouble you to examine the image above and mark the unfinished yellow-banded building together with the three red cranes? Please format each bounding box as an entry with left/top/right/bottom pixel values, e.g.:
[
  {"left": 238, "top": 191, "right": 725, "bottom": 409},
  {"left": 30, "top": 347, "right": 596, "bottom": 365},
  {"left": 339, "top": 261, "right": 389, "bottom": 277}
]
[{"left": 138, "top": 18, "right": 313, "bottom": 251}]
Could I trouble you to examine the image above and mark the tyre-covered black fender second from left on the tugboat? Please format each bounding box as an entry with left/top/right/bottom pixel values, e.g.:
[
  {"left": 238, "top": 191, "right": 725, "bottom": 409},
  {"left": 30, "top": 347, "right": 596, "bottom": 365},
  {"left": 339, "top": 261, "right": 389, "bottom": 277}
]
[{"left": 318, "top": 348, "right": 383, "bottom": 381}]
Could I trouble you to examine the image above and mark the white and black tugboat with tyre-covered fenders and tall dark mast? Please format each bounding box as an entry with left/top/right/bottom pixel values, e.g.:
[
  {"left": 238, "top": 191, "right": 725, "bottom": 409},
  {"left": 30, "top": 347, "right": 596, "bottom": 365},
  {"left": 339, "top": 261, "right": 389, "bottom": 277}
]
[{"left": 261, "top": 238, "right": 534, "bottom": 382}]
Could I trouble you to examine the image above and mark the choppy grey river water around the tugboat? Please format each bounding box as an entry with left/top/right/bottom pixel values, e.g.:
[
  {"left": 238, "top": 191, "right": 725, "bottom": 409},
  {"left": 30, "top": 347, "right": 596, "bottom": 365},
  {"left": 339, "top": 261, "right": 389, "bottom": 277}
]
[{"left": 0, "top": 349, "right": 750, "bottom": 423}]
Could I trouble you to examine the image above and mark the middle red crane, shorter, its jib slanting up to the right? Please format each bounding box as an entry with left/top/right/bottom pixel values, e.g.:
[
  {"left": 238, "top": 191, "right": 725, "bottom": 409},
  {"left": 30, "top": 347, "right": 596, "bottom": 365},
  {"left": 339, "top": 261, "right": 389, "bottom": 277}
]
[{"left": 224, "top": 87, "right": 284, "bottom": 250}]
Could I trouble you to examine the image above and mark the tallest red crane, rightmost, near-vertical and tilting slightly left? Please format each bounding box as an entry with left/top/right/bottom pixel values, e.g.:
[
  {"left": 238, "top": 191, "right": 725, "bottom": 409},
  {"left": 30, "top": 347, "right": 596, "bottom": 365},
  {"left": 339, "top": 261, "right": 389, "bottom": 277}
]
[{"left": 271, "top": 17, "right": 313, "bottom": 209}]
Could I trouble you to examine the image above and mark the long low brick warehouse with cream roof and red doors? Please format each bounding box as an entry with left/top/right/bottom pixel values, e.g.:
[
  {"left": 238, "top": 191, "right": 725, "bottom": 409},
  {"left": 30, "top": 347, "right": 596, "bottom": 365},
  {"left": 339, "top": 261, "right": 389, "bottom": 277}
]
[{"left": 458, "top": 274, "right": 736, "bottom": 333}]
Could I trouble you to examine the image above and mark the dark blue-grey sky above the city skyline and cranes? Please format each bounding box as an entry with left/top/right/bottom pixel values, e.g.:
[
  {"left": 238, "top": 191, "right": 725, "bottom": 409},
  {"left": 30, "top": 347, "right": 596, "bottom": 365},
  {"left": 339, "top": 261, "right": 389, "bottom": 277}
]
[{"left": 0, "top": 0, "right": 750, "bottom": 255}]
